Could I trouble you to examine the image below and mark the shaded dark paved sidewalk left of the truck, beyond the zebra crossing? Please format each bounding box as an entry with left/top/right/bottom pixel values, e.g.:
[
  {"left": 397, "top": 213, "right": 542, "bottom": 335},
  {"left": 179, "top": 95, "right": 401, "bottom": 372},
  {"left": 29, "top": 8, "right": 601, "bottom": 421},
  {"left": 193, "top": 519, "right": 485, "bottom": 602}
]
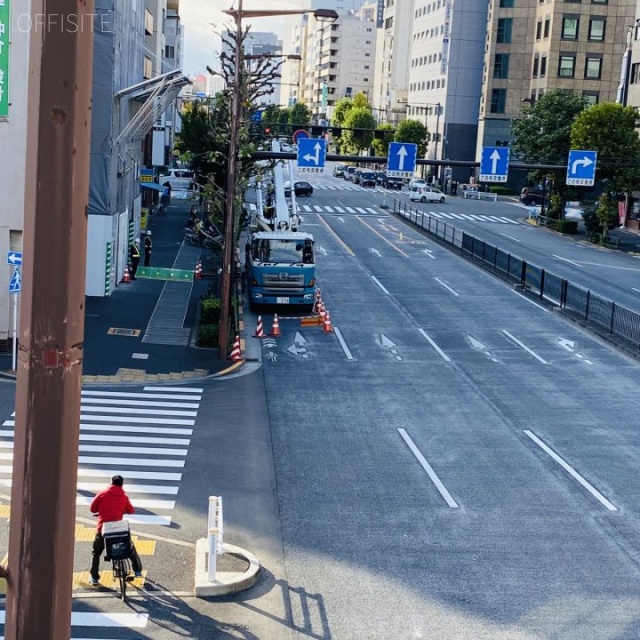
[{"left": 83, "top": 199, "right": 232, "bottom": 383}]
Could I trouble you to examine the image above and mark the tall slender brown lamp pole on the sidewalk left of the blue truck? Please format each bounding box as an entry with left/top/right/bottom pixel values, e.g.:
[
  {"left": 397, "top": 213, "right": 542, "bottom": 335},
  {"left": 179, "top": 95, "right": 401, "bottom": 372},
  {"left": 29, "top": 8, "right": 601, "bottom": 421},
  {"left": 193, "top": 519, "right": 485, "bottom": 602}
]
[{"left": 218, "top": 0, "right": 242, "bottom": 360}]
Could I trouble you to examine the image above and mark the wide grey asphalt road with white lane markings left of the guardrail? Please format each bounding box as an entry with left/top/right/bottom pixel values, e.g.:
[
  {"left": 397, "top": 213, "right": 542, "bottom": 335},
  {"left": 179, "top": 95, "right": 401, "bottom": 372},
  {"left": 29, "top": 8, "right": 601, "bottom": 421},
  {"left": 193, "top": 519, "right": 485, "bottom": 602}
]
[{"left": 0, "top": 171, "right": 640, "bottom": 640}]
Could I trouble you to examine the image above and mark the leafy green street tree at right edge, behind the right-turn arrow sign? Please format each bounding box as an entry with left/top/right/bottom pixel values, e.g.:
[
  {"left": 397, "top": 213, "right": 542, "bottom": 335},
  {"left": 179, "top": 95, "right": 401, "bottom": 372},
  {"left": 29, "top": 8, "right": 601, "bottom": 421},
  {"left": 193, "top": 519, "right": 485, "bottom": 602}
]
[{"left": 571, "top": 102, "right": 640, "bottom": 192}]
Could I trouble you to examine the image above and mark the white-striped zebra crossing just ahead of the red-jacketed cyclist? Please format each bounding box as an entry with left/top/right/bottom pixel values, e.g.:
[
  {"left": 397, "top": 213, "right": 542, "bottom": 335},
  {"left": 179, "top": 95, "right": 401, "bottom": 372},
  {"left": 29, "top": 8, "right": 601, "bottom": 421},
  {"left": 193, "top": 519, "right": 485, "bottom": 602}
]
[{"left": 0, "top": 386, "right": 203, "bottom": 528}]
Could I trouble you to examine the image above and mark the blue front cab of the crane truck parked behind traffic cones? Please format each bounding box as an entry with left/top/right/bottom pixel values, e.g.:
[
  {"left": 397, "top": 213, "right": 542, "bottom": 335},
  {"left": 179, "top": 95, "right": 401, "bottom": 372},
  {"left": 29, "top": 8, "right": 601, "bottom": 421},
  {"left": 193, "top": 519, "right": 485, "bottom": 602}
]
[{"left": 245, "top": 231, "right": 316, "bottom": 310}]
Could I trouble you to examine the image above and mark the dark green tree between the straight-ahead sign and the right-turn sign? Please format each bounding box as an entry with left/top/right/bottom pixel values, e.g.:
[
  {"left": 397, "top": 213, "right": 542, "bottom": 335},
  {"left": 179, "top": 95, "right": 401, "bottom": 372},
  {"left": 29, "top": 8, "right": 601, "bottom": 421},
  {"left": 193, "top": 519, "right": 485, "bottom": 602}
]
[{"left": 511, "top": 89, "right": 589, "bottom": 194}]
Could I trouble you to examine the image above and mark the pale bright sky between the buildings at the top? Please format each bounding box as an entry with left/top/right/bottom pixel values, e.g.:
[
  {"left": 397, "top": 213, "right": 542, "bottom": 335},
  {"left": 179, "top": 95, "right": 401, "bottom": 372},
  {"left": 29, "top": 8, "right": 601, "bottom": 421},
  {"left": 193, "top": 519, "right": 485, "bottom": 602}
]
[{"left": 180, "top": 0, "right": 301, "bottom": 75}]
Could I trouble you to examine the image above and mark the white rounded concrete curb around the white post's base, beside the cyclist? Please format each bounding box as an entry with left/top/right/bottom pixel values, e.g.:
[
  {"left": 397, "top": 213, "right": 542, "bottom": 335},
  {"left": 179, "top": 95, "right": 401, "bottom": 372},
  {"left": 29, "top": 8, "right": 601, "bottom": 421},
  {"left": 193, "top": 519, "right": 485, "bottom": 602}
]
[{"left": 195, "top": 538, "right": 260, "bottom": 598}]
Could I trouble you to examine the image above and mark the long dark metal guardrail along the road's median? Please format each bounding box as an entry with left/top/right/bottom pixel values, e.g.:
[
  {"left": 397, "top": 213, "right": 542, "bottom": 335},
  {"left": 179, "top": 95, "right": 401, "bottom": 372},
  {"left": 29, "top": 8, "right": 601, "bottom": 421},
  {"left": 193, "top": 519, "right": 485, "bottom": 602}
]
[{"left": 393, "top": 200, "right": 640, "bottom": 349}]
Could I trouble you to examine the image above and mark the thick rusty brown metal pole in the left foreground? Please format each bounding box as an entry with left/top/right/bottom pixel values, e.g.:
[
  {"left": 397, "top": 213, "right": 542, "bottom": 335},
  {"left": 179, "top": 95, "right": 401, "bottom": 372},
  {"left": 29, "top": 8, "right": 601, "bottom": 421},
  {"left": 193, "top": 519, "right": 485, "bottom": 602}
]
[{"left": 5, "top": 0, "right": 94, "bottom": 640}]
